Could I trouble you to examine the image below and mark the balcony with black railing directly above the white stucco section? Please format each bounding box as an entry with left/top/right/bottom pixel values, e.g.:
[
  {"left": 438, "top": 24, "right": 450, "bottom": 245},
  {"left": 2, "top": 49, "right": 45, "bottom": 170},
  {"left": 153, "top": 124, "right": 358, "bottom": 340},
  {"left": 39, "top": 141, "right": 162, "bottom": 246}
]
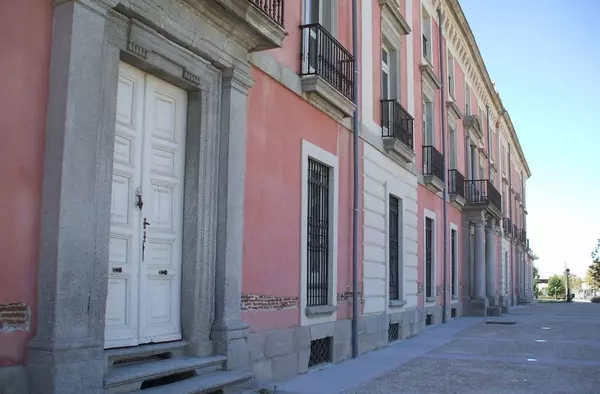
[{"left": 381, "top": 100, "right": 415, "bottom": 163}]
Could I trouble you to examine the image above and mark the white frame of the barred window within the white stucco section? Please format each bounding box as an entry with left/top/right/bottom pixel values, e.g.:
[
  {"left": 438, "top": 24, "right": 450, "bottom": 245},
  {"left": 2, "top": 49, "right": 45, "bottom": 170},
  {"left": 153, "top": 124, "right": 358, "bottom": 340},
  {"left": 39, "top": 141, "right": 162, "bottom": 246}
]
[{"left": 385, "top": 181, "right": 407, "bottom": 312}]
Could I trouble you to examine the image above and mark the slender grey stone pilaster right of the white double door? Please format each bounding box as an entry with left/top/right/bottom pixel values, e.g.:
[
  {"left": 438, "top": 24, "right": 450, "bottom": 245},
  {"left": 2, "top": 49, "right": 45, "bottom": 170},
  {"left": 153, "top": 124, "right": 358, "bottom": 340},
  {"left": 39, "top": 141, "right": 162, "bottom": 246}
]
[{"left": 211, "top": 69, "right": 253, "bottom": 369}]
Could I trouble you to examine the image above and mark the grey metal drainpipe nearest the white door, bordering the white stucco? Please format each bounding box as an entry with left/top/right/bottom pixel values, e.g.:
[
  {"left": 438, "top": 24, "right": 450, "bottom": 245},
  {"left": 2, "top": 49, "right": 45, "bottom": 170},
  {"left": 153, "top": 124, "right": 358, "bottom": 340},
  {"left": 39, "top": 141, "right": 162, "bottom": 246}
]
[{"left": 352, "top": 0, "right": 360, "bottom": 358}]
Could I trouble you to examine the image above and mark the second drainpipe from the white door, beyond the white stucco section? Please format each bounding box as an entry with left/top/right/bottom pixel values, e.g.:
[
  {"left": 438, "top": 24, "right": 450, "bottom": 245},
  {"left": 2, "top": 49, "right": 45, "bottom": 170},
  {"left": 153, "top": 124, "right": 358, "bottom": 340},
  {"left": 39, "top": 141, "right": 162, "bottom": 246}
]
[{"left": 437, "top": 8, "right": 448, "bottom": 323}]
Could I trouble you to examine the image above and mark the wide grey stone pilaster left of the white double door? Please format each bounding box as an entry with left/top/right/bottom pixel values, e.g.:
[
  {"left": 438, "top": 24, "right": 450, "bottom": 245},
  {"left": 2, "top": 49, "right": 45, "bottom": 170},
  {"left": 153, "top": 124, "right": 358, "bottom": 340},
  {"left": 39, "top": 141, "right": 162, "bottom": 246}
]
[{"left": 27, "top": 0, "right": 119, "bottom": 394}]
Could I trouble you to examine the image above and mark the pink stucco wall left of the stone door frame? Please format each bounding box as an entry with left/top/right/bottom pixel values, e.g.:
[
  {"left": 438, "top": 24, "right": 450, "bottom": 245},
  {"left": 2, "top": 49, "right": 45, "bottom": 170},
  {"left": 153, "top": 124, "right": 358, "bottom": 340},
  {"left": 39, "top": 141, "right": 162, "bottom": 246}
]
[{"left": 0, "top": 0, "right": 53, "bottom": 367}]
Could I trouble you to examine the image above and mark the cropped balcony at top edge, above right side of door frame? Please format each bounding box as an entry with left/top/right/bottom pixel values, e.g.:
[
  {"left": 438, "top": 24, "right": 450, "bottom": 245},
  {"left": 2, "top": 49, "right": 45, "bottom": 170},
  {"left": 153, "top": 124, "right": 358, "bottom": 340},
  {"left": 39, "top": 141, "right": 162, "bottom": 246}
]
[{"left": 212, "top": 0, "right": 287, "bottom": 52}]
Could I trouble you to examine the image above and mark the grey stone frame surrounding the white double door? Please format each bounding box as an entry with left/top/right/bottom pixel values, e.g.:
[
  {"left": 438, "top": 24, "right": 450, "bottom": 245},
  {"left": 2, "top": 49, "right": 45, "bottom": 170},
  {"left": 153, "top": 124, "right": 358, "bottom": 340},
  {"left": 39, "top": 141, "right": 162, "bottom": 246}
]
[{"left": 27, "top": 0, "right": 253, "bottom": 393}]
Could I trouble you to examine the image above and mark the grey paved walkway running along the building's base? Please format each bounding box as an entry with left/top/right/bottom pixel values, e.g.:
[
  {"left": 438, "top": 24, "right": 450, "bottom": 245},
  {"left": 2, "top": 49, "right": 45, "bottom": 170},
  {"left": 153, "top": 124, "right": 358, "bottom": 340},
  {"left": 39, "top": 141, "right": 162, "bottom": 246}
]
[{"left": 276, "top": 303, "right": 600, "bottom": 394}]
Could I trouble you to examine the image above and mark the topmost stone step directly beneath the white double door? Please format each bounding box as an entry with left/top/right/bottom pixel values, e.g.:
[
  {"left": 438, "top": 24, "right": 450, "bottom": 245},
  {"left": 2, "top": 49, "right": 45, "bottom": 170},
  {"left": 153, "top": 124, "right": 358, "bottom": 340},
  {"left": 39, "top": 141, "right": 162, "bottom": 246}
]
[{"left": 104, "top": 341, "right": 188, "bottom": 372}]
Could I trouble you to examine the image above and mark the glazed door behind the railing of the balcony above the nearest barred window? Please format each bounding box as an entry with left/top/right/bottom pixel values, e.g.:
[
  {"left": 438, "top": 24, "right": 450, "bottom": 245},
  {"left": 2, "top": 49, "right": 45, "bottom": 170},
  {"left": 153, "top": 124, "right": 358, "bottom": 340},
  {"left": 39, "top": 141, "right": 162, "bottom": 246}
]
[{"left": 303, "top": 0, "right": 337, "bottom": 74}]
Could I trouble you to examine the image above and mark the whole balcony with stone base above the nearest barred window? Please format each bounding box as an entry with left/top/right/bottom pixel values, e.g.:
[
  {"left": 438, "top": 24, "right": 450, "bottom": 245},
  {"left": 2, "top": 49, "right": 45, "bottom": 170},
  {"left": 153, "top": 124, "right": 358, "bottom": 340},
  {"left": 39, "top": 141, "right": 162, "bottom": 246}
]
[{"left": 300, "top": 23, "right": 356, "bottom": 119}]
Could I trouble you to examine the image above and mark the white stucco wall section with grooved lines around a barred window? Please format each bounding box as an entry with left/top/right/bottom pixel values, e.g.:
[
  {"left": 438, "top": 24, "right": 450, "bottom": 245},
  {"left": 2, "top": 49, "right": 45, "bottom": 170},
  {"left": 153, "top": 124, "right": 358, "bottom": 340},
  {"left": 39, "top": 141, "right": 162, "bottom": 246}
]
[{"left": 363, "top": 143, "right": 418, "bottom": 315}]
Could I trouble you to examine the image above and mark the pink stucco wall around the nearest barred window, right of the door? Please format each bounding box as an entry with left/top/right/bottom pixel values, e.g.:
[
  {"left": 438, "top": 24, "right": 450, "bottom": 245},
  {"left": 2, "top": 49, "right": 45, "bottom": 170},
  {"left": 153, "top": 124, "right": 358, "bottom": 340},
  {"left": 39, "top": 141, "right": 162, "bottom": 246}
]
[{"left": 242, "top": 69, "right": 362, "bottom": 331}]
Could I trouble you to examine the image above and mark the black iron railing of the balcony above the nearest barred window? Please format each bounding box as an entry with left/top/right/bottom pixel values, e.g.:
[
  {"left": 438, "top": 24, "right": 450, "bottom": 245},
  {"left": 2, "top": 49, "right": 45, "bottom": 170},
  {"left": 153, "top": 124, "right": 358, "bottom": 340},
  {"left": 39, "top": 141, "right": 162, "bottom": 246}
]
[{"left": 300, "top": 23, "right": 354, "bottom": 101}]
